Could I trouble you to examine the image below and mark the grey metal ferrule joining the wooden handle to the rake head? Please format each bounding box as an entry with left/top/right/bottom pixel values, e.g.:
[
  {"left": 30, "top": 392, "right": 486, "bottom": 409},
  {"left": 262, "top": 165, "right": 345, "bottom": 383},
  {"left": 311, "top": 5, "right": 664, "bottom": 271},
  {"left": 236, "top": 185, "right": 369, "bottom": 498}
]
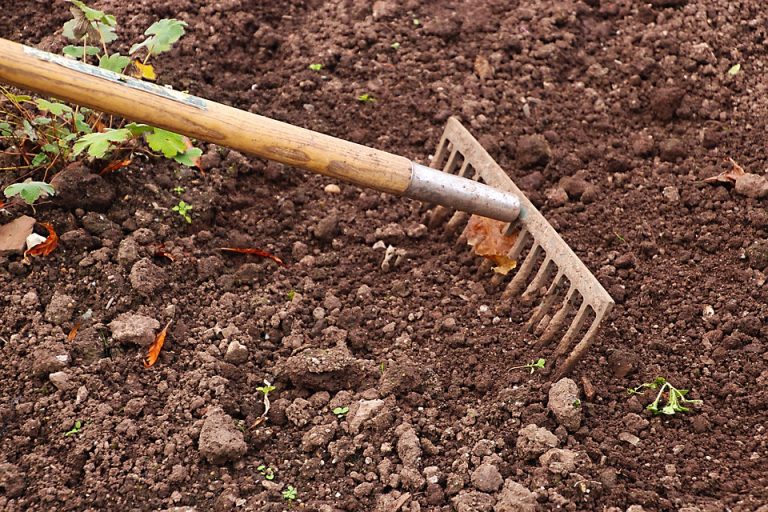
[{"left": 403, "top": 162, "right": 520, "bottom": 222}]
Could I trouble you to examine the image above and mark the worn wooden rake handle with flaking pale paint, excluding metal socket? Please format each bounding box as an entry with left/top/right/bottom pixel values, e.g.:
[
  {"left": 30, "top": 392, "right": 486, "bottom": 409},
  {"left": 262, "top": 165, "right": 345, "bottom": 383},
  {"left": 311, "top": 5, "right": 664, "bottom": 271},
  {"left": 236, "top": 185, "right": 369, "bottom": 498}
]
[{"left": 0, "top": 39, "right": 412, "bottom": 195}]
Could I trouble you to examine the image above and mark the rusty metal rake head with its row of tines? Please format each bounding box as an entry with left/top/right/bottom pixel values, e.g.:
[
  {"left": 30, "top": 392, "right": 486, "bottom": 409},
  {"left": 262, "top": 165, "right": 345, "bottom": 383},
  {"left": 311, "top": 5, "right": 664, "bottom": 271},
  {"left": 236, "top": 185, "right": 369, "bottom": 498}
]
[{"left": 430, "top": 118, "right": 614, "bottom": 379}]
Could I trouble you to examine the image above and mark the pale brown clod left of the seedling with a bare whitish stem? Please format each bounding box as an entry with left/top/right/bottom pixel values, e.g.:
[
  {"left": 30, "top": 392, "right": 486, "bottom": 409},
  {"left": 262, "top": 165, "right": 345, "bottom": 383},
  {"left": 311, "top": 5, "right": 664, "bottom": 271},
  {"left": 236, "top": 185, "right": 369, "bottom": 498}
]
[{"left": 198, "top": 407, "right": 248, "bottom": 466}]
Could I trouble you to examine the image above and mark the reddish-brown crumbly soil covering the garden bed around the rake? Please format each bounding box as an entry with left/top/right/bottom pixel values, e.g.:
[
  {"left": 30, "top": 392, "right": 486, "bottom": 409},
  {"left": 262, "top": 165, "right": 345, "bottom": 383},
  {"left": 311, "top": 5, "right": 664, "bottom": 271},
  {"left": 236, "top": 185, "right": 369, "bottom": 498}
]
[{"left": 0, "top": 0, "right": 768, "bottom": 512}]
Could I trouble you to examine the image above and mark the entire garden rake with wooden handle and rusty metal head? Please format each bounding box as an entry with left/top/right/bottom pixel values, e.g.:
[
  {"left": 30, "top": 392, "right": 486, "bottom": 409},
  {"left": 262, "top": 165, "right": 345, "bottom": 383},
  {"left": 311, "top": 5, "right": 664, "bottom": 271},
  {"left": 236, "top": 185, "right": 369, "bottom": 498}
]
[{"left": 0, "top": 39, "right": 613, "bottom": 376}]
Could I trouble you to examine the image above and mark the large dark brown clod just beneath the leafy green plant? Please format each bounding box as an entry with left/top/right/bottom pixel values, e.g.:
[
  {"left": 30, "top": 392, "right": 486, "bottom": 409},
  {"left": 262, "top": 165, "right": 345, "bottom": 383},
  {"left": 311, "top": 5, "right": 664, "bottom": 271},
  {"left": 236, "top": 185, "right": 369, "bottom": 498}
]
[{"left": 51, "top": 162, "right": 115, "bottom": 211}]
